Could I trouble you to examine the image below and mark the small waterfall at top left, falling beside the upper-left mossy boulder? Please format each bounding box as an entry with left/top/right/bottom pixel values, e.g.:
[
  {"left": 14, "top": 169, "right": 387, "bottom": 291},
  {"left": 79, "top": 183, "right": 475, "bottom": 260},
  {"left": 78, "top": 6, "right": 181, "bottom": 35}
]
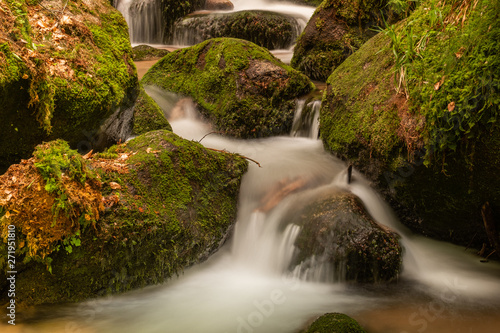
[{"left": 114, "top": 0, "right": 164, "bottom": 44}]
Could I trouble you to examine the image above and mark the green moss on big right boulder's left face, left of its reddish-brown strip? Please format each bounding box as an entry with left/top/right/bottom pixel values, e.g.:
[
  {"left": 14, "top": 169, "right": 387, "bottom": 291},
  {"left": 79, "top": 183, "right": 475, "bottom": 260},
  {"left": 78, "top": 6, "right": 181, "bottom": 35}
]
[{"left": 320, "top": 35, "right": 399, "bottom": 159}]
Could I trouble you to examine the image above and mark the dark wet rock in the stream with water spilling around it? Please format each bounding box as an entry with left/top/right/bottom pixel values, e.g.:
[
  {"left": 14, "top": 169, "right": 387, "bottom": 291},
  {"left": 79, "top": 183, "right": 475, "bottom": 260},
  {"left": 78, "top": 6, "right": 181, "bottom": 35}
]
[{"left": 290, "top": 193, "right": 402, "bottom": 283}]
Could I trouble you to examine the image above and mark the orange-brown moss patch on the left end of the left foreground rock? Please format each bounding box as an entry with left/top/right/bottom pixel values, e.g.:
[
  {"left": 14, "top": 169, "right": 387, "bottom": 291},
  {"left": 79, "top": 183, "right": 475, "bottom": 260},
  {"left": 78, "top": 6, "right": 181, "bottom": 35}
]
[{"left": 0, "top": 152, "right": 104, "bottom": 259}]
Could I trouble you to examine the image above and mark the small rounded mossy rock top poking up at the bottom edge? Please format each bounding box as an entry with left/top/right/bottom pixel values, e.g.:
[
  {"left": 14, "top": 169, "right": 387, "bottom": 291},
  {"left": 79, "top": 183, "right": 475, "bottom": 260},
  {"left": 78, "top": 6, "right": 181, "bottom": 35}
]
[{"left": 302, "top": 313, "right": 366, "bottom": 333}]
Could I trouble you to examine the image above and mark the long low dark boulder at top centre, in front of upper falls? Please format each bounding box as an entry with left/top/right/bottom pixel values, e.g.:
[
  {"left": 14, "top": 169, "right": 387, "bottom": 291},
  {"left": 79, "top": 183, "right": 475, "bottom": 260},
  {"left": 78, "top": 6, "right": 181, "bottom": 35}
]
[{"left": 174, "top": 10, "right": 300, "bottom": 50}]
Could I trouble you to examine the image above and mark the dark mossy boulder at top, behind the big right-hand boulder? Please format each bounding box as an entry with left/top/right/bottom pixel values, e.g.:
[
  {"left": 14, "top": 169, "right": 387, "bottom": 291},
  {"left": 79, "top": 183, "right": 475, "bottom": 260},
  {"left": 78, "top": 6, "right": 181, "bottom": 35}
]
[{"left": 291, "top": 0, "right": 396, "bottom": 82}]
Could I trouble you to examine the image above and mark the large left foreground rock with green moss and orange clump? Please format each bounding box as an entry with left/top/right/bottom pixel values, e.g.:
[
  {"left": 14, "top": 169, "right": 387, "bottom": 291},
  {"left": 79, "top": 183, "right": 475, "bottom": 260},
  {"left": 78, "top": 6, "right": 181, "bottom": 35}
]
[{"left": 0, "top": 131, "right": 247, "bottom": 305}]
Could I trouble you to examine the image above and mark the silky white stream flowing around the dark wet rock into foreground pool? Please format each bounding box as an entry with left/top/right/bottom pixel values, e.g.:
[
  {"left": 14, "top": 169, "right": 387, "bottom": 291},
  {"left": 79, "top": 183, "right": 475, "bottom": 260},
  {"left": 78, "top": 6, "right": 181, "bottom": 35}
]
[{"left": 6, "top": 92, "right": 500, "bottom": 333}]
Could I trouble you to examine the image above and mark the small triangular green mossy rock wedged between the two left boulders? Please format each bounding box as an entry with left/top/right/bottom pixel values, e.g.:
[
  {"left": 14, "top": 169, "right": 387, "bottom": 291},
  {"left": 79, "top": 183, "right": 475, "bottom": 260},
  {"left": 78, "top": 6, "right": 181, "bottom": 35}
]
[{"left": 132, "top": 87, "right": 172, "bottom": 135}]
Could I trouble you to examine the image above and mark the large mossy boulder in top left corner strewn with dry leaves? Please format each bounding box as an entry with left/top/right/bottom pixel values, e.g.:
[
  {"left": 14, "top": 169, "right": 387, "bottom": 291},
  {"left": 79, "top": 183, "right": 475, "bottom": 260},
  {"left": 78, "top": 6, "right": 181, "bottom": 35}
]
[{"left": 0, "top": 0, "right": 139, "bottom": 172}]
